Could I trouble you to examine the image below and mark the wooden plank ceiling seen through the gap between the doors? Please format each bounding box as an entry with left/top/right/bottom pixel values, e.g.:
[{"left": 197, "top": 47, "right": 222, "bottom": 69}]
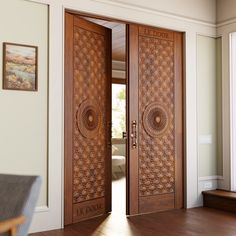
[{"left": 84, "top": 17, "right": 126, "bottom": 61}]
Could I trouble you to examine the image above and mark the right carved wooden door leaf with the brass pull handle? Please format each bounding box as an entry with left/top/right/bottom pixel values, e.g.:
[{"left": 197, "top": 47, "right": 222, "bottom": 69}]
[{"left": 127, "top": 25, "right": 183, "bottom": 215}]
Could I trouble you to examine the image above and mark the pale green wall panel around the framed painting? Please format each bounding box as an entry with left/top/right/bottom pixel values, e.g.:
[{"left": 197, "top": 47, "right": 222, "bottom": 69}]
[{"left": 0, "top": 0, "right": 48, "bottom": 206}]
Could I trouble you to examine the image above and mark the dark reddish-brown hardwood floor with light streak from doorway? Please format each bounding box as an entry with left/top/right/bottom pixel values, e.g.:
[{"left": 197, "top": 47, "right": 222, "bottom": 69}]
[{"left": 31, "top": 208, "right": 236, "bottom": 236}]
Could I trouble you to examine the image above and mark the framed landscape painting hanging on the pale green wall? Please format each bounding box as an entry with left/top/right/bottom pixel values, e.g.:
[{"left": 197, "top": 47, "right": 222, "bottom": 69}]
[{"left": 3, "top": 43, "right": 38, "bottom": 91}]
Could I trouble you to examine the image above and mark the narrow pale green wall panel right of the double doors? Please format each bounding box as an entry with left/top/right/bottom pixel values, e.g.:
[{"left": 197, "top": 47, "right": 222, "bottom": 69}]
[{"left": 197, "top": 35, "right": 217, "bottom": 177}]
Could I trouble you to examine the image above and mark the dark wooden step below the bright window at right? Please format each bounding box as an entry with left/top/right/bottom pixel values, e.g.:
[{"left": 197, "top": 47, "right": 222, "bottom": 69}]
[{"left": 202, "top": 189, "right": 236, "bottom": 213}]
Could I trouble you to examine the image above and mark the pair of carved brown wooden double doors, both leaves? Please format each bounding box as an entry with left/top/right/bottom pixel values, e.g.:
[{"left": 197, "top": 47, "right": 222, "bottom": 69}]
[{"left": 64, "top": 13, "right": 183, "bottom": 224}]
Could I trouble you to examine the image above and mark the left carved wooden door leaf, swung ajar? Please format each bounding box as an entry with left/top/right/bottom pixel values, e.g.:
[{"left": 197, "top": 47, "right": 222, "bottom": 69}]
[{"left": 64, "top": 13, "right": 111, "bottom": 225}]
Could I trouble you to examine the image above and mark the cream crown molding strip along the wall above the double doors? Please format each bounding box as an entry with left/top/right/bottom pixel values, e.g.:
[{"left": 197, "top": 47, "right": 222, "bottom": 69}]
[{"left": 92, "top": 0, "right": 216, "bottom": 27}]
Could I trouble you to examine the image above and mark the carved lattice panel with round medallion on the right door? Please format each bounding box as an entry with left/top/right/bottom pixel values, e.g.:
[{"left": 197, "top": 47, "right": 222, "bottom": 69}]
[{"left": 139, "top": 34, "right": 175, "bottom": 196}]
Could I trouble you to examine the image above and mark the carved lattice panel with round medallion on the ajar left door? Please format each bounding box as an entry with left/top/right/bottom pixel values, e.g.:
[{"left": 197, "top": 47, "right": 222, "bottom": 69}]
[{"left": 73, "top": 27, "right": 106, "bottom": 203}]
